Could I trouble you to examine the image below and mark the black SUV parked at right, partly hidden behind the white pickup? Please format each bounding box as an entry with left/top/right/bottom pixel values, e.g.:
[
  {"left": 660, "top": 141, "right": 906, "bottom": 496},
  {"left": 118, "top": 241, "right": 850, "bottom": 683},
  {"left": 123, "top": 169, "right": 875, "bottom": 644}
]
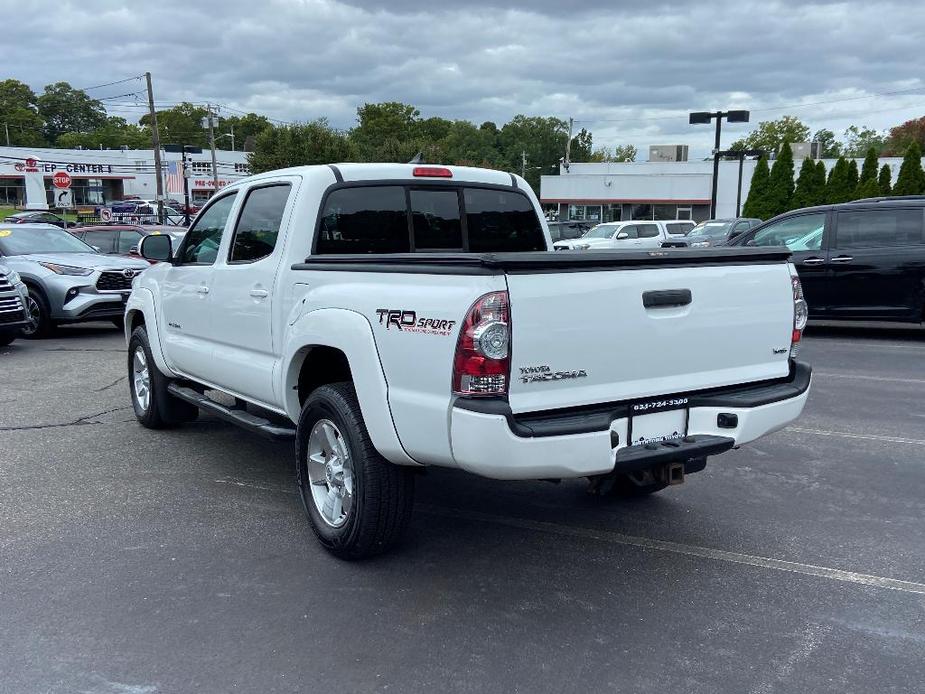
[{"left": 730, "top": 198, "right": 925, "bottom": 323}]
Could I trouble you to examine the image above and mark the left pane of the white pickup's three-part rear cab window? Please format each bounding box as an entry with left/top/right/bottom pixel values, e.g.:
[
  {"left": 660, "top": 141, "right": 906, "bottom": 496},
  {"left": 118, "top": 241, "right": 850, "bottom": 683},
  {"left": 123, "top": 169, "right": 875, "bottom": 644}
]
[{"left": 316, "top": 186, "right": 411, "bottom": 253}]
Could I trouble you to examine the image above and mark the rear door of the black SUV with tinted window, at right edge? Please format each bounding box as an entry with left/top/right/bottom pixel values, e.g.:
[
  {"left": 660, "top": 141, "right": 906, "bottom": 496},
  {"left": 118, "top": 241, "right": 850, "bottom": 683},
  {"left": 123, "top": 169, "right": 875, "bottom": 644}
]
[{"left": 829, "top": 205, "right": 925, "bottom": 321}]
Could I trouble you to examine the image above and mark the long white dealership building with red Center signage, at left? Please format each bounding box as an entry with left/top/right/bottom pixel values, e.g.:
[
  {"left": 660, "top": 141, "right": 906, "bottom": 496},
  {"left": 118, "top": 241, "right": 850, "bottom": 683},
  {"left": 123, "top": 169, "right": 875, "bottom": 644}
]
[{"left": 0, "top": 147, "right": 248, "bottom": 206}]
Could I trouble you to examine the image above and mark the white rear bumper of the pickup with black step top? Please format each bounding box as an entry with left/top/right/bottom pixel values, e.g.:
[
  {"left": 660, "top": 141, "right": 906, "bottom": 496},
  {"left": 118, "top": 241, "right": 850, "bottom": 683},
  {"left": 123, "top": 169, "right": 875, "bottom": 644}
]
[{"left": 450, "top": 363, "right": 812, "bottom": 479}]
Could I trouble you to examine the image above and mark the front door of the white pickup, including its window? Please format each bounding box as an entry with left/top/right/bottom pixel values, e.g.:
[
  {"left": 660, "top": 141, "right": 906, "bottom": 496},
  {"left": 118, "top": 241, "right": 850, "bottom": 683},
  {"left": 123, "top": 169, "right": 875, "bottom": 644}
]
[{"left": 160, "top": 193, "right": 235, "bottom": 379}]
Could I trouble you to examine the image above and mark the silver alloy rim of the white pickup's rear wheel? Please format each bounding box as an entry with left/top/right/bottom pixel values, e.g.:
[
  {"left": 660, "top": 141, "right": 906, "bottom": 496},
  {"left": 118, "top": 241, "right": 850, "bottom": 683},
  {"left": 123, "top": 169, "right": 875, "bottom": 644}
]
[{"left": 307, "top": 419, "right": 355, "bottom": 528}]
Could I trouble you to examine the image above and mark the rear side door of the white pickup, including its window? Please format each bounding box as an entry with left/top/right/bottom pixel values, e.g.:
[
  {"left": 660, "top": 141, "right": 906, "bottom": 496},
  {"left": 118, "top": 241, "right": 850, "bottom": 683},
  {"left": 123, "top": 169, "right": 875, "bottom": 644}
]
[{"left": 211, "top": 181, "right": 293, "bottom": 405}]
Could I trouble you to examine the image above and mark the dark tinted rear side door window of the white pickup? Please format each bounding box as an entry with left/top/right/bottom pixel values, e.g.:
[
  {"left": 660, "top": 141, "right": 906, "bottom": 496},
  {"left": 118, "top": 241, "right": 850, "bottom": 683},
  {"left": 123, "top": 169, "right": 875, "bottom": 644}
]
[{"left": 229, "top": 183, "right": 292, "bottom": 263}]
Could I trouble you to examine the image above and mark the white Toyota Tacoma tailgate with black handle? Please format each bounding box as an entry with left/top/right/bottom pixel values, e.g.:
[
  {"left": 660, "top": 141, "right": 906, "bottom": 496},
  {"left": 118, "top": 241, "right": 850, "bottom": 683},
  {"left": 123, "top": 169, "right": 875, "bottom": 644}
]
[{"left": 507, "top": 251, "right": 793, "bottom": 413}]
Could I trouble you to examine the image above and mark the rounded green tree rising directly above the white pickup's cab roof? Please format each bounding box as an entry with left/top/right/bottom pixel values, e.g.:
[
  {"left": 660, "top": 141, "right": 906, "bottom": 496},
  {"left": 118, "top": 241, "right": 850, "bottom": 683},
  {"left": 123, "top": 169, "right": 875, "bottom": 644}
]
[{"left": 247, "top": 118, "right": 356, "bottom": 173}]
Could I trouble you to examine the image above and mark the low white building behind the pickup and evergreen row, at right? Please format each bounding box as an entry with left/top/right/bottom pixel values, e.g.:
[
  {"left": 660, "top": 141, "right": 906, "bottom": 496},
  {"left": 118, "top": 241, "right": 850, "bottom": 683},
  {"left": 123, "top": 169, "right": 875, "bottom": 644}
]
[{"left": 540, "top": 157, "right": 902, "bottom": 222}]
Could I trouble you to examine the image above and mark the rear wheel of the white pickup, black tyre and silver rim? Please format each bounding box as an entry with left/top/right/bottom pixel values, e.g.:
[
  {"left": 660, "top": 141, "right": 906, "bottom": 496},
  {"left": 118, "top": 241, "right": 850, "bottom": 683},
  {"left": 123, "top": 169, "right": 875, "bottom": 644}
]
[{"left": 296, "top": 383, "right": 414, "bottom": 559}]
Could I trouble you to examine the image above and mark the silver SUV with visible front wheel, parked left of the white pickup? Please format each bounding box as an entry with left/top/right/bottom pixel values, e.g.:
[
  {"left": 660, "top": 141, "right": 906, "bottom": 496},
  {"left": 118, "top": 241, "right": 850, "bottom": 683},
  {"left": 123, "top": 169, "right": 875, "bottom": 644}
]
[{"left": 0, "top": 224, "right": 150, "bottom": 337}]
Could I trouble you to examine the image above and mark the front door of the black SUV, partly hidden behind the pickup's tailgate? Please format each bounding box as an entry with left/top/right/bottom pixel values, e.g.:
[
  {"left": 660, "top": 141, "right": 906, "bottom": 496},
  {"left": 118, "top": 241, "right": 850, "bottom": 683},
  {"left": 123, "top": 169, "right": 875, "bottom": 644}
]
[{"left": 747, "top": 212, "right": 831, "bottom": 318}]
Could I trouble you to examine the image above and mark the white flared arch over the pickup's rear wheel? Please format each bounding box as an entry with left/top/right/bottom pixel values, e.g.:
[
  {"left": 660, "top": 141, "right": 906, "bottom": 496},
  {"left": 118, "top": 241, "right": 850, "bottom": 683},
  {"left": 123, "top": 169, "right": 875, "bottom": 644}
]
[{"left": 279, "top": 308, "right": 419, "bottom": 465}]
